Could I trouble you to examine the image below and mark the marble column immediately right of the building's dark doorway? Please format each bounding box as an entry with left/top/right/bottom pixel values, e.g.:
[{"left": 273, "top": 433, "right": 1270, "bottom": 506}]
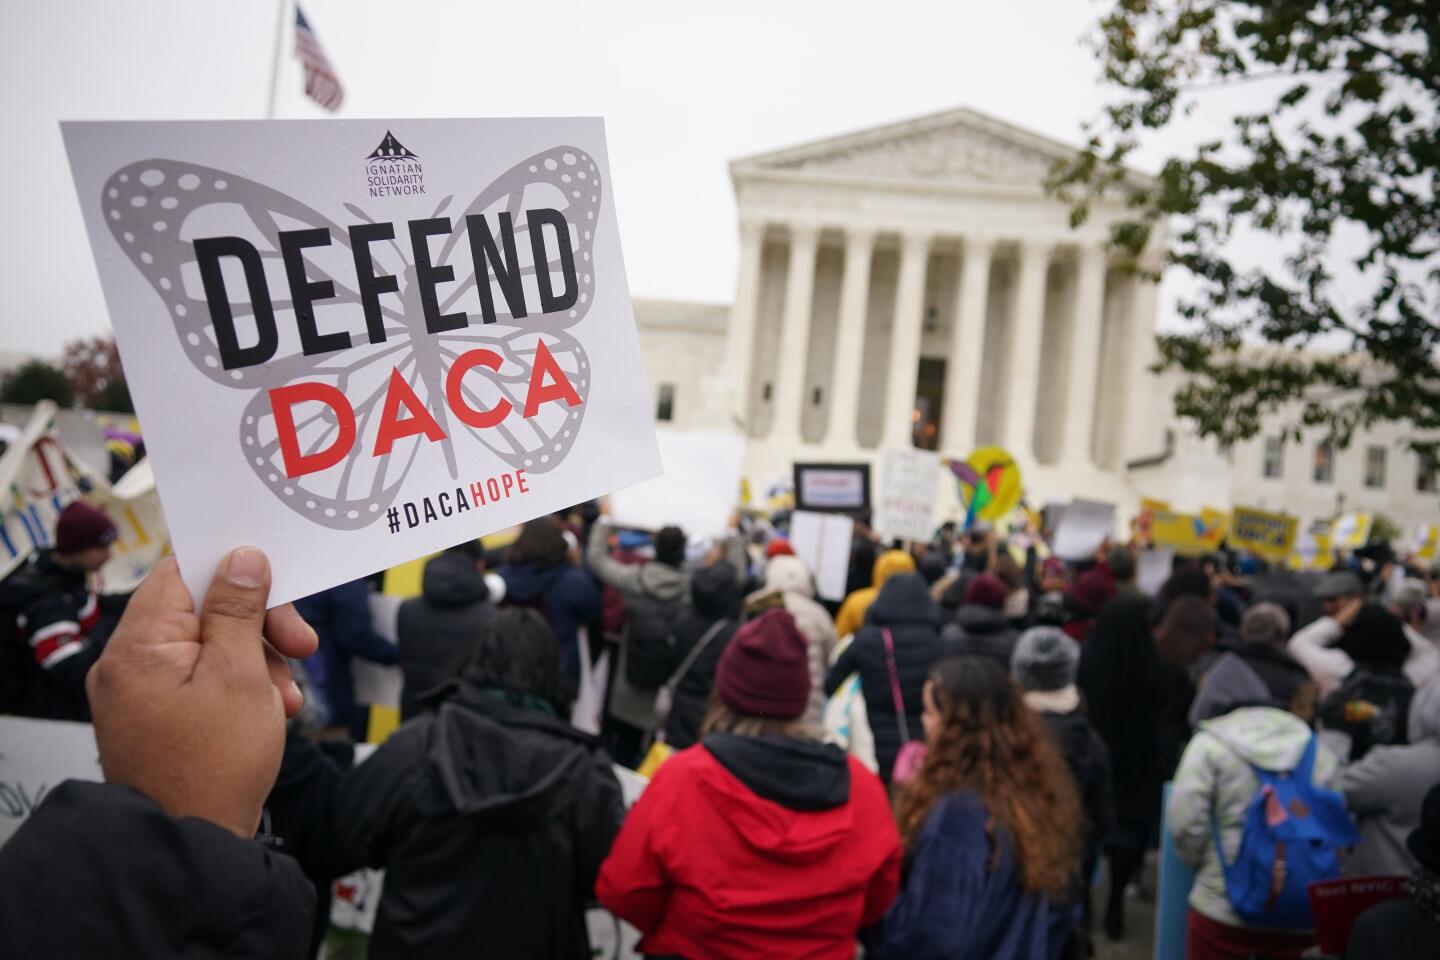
[{"left": 940, "top": 236, "right": 995, "bottom": 456}]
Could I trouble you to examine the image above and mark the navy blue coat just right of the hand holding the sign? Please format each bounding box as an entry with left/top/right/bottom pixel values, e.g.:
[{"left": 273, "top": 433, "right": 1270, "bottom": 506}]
[{"left": 295, "top": 580, "right": 399, "bottom": 730}]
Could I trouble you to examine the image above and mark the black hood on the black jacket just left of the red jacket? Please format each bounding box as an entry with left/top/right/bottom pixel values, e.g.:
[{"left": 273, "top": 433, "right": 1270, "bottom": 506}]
[{"left": 429, "top": 681, "right": 598, "bottom": 825}]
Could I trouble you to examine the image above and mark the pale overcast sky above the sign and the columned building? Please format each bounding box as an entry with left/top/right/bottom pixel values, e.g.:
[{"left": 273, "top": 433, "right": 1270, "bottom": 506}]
[{"left": 0, "top": 0, "right": 1244, "bottom": 356}]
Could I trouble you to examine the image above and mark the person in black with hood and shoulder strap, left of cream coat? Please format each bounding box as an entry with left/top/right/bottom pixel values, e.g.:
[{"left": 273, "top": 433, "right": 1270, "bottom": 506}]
[{"left": 665, "top": 560, "right": 742, "bottom": 750}]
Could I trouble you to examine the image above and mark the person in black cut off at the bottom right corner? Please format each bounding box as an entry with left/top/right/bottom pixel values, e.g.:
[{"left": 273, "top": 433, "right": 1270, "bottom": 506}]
[{"left": 1345, "top": 784, "right": 1440, "bottom": 960}]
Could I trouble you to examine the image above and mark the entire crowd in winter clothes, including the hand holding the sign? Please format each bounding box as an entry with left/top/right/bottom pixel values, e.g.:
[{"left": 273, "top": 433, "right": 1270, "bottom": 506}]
[{"left": 0, "top": 504, "right": 1440, "bottom": 960}]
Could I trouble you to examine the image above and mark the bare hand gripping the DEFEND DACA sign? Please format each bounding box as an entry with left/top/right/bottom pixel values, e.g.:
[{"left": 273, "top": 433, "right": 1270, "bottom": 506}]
[{"left": 85, "top": 547, "right": 315, "bottom": 836}]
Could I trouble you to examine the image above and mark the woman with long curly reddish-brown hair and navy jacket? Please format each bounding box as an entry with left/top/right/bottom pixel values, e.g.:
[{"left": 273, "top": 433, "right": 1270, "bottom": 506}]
[{"left": 865, "top": 656, "right": 1083, "bottom": 960}]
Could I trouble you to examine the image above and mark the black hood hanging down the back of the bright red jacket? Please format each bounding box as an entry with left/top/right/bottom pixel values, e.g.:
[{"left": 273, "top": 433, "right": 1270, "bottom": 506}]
[{"left": 703, "top": 734, "right": 850, "bottom": 810}]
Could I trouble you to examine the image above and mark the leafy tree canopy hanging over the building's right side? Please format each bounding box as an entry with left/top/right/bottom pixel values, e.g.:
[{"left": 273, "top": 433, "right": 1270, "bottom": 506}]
[{"left": 1051, "top": 0, "right": 1440, "bottom": 455}]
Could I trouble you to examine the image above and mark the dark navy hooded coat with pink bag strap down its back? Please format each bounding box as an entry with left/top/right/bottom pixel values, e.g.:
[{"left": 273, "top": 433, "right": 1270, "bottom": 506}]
[{"left": 825, "top": 573, "right": 955, "bottom": 783}]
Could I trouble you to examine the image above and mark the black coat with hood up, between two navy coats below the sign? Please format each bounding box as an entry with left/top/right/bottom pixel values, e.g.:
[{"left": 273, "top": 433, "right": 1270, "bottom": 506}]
[{"left": 395, "top": 550, "right": 495, "bottom": 723}]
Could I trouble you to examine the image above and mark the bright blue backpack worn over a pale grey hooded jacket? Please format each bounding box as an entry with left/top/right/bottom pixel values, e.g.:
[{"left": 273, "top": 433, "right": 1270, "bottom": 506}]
[{"left": 1211, "top": 734, "right": 1359, "bottom": 930}]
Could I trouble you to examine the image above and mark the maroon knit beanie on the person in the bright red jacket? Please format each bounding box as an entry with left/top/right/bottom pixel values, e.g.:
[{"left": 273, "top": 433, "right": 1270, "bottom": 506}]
[{"left": 716, "top": 607, "right": 811, "bottom": 720}]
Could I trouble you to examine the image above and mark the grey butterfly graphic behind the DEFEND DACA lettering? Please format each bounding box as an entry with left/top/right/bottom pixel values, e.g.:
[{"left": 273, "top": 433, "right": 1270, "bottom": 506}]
[{"left": 99, "top": 145, "right": 602, "bottom": 530}]
